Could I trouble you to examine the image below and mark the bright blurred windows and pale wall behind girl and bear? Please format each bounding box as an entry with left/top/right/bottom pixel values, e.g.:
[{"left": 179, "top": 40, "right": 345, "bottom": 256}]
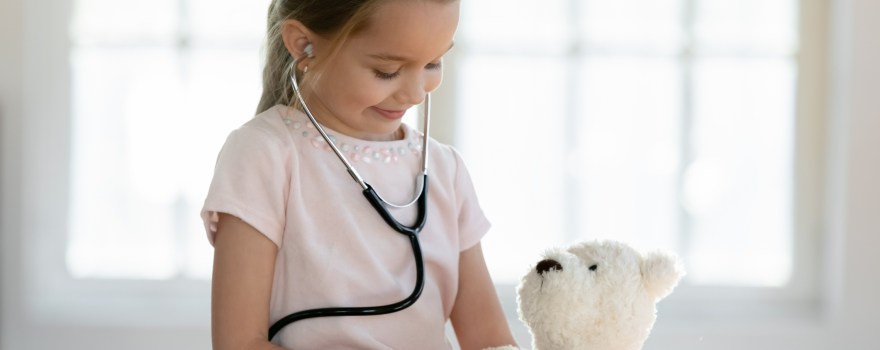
[{"left": 0, "top": 0, "right": 880, "bottom": 350}]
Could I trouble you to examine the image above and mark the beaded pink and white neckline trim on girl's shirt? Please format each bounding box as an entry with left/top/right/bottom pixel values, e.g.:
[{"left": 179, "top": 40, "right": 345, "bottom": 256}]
[{"left": 284, "top": 118, "right": 424, "bottom": 164}]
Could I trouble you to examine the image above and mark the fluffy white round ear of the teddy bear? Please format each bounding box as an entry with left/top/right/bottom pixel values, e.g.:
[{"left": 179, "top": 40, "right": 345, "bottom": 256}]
[{"left": 640, "top": 250, "right": 685, "bottom": 300}]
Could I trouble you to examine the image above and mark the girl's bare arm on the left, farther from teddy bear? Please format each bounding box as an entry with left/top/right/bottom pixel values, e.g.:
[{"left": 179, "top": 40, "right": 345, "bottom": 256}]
[{"left": 211, "top": 213, "right": 281, "bottom": 350}]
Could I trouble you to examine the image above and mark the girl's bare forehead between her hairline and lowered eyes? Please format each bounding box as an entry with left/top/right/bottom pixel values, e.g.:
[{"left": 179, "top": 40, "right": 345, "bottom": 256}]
[{"left": 350, "top": 0, "right": 459, "bottom": 59}]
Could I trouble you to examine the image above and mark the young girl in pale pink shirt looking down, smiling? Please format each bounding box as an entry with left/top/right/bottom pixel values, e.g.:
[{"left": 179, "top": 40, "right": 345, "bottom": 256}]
[{"left": 202, "top": 0, "right": 514, "bottom": 350}]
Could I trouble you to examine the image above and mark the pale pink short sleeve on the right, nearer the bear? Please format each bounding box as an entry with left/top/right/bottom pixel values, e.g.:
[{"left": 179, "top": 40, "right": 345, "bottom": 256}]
[{"left": 452, "top": 149, "right": 492, "bottom": 251}]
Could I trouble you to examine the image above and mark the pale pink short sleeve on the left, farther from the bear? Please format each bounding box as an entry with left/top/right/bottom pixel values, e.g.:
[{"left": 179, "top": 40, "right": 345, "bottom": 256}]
[{"left": 201, "top": 124, "right": 290, "bottom": 246}]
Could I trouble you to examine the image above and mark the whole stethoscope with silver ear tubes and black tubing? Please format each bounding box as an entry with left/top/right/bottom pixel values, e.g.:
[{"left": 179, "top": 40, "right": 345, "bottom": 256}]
[{"left": 269, "top": 44, "right": 431, "bottom": 340}]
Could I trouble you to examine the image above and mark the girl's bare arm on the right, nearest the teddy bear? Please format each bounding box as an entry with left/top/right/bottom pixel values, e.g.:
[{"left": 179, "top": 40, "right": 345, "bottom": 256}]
[{"left": 450, "top": 243, "right": 516, "bottom": 350}]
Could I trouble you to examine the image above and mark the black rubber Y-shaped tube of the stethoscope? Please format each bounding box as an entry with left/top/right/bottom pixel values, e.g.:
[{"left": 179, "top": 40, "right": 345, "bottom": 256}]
[{"left": 269, "top": 174, "right": 428, "bottom": 340}]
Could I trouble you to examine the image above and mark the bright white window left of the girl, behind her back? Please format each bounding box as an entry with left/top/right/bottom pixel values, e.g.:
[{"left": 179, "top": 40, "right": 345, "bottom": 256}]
[{"left": 66, "top": 0, "right": 268, "bottom": 280}]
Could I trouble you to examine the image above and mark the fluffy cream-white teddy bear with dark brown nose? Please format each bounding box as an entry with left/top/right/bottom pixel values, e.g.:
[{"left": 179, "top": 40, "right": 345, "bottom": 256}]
[{"left": 487, "top": 240, "right": 685, "bottom": 350}]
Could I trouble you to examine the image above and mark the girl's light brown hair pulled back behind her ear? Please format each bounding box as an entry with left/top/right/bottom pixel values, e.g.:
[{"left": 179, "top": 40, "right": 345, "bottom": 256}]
[{"left": 257, "top": 0, "right": 387, "bottom": 114}]
